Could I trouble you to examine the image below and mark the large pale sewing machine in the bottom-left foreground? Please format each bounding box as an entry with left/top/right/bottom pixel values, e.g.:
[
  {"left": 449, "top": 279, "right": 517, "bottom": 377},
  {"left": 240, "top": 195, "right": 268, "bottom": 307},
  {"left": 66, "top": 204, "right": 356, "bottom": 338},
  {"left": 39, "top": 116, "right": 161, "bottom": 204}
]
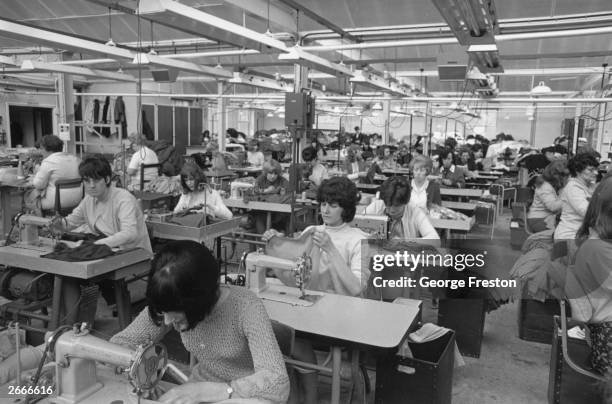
[{"left": 16, "top": 324, "right": 168, "bottom": 404}]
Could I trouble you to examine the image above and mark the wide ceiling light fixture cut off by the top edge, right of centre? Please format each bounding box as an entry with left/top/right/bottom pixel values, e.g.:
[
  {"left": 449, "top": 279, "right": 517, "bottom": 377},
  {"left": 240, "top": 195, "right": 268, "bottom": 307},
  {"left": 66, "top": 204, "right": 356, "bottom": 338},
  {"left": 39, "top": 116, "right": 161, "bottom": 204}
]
[{"left": 432, "top": 0, "right": 499, "bottom": 46}]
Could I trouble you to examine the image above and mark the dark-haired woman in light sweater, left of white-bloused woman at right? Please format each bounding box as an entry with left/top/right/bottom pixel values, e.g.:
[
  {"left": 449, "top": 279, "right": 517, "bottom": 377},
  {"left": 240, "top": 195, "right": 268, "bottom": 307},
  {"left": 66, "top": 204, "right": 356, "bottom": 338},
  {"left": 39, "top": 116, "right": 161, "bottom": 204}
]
[{"left": 527, "top": 160, "right": 569, "bottom": 233}]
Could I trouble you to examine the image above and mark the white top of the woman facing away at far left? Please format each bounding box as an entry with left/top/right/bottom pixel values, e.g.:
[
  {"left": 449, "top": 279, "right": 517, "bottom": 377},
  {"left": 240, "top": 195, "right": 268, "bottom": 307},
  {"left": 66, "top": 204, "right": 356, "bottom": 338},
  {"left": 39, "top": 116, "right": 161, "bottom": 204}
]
[{"left": 32, "top": 152, "right": 83, "bottom": 210}]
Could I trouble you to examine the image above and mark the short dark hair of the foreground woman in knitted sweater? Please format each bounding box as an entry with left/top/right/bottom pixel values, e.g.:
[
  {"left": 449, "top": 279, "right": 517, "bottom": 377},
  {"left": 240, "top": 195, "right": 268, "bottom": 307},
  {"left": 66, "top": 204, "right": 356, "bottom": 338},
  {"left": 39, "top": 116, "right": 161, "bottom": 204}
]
[{"left": 146, "top": 240, "right": 220, "bottom": 330}]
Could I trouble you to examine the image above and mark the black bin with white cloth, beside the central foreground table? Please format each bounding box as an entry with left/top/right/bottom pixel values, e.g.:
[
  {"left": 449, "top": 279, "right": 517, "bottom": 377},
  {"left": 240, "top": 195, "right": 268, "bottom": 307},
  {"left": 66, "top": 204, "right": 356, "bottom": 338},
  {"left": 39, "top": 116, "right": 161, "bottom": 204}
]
[{"left": 374, "top": 331, "right": 455, "bottom": 404}]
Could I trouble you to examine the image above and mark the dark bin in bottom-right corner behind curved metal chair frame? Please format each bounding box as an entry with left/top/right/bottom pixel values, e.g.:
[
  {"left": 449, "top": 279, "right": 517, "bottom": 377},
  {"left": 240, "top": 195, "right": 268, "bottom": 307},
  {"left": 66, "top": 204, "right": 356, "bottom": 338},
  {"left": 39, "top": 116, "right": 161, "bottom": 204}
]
[{"left": 548, "top": 317, "right": 603, "bottom": 404}]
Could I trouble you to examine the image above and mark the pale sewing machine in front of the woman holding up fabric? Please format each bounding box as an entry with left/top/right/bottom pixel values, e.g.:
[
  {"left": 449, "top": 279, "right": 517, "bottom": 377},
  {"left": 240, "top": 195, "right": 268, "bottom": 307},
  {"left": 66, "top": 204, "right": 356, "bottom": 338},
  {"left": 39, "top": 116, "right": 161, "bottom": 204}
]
[{"left": 242, "top": 249, "right": 321, "bottom": 306}]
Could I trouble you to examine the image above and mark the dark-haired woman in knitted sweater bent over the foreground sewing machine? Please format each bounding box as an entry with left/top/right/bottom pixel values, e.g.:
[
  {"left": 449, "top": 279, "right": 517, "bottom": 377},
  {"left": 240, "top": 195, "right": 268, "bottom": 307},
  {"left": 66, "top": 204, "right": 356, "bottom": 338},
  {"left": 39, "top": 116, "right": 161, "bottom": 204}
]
[{"left": 0, "top": 240, "right": 289, "bottom": 404}]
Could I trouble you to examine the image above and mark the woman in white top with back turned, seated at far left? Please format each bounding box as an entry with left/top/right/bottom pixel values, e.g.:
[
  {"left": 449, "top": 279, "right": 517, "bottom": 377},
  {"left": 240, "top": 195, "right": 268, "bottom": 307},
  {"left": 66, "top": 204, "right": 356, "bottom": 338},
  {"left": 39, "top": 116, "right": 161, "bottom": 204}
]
[{"left": 25, "top": 135, "right": 83, "bottom": 215}]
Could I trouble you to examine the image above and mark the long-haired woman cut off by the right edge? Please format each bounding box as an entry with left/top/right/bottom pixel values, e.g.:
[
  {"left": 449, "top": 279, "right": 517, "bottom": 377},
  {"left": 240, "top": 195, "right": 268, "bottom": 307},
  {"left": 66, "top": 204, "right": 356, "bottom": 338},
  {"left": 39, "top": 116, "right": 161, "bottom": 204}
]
[{"left": 565, "top": 178, "right": 612, "bottom": 376}]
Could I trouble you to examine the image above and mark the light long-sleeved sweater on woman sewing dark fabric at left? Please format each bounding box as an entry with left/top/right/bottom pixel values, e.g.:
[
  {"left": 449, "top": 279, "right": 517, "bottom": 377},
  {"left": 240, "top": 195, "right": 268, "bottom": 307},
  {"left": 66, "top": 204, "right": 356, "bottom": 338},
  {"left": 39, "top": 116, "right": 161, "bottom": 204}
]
[{"left": 66, "top": 186, "right": 152, "bottom": 251}]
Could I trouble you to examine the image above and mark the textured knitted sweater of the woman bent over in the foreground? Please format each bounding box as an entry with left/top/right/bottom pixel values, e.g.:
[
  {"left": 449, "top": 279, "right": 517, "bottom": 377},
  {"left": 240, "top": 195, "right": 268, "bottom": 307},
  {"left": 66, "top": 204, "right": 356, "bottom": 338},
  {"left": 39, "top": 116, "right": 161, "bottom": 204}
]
[{"left": 110, "top": 285, "right": 289, "bottom": 404}]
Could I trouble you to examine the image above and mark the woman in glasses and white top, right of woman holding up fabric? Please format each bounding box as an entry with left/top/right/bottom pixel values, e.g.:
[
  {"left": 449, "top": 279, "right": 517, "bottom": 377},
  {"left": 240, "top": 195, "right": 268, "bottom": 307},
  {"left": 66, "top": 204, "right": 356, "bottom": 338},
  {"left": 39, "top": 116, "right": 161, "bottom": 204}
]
[{"left": 365, "top": 176, "right": 440, "bottom": 247}]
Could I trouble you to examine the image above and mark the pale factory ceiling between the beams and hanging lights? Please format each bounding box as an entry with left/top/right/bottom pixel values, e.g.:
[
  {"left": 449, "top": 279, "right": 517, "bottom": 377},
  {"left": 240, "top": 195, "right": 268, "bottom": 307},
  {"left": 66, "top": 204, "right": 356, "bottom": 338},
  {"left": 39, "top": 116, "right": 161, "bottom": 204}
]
[{"left": 0, "top": 0, "right": 612, "bottom": 95}]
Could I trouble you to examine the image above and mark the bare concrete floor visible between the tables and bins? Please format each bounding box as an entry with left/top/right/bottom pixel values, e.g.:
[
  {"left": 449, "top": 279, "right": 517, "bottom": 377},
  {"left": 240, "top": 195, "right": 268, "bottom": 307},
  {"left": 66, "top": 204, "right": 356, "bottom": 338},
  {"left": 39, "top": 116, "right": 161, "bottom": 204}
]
[{"left": 96, "top": 209, "right": 550, "bottom": 404}]
